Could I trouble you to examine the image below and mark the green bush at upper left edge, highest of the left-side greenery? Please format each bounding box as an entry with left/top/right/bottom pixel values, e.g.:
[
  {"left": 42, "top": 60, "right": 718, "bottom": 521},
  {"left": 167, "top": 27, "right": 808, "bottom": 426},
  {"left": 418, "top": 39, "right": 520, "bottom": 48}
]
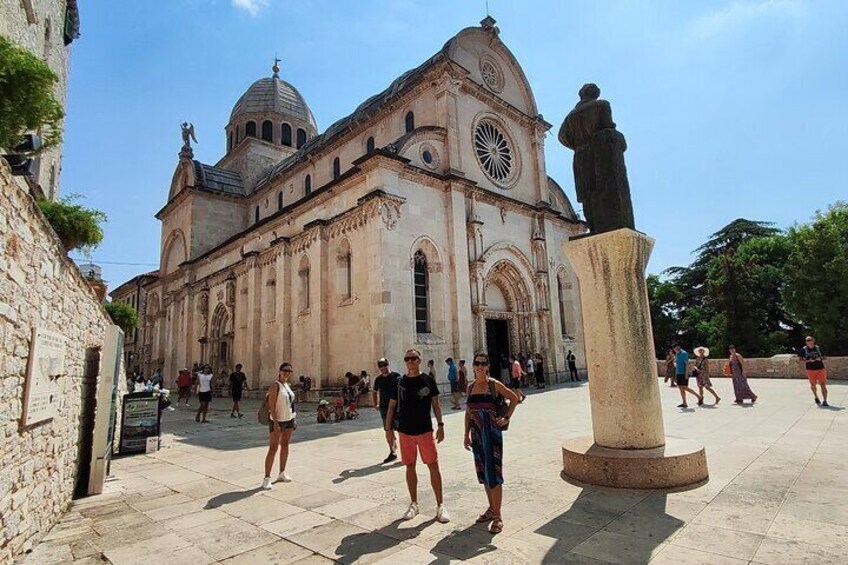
[{"left": 0, "top": 36, "right": 64, "bottom": 149}]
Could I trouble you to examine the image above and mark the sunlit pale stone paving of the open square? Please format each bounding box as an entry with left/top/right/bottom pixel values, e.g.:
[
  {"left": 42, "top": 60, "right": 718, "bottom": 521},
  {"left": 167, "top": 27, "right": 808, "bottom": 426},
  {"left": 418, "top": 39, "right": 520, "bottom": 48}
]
[{"left": 22, "top": 379, "right": 848, "bottom": 565}]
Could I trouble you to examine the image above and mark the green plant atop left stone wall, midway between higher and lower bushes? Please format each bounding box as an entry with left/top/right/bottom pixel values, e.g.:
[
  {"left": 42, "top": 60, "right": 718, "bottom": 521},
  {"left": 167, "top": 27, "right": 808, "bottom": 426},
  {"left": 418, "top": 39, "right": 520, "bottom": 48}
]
[{"left": 38, "top": 194, "right": 106, "bottom": 252}]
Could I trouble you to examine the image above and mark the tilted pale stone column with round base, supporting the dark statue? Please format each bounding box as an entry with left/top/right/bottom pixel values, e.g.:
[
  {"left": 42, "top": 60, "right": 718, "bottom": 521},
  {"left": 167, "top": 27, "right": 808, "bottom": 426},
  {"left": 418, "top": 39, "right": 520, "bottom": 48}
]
[{"left": 563, "top": 228, "right": 707, "bottom": 488}]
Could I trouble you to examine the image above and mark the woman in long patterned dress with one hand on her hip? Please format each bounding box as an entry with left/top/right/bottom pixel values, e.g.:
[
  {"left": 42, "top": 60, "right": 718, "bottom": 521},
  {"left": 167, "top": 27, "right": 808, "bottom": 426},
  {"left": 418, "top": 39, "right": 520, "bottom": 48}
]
[{"left": 463, "top": 352, "right": 518, "bottom": 534}]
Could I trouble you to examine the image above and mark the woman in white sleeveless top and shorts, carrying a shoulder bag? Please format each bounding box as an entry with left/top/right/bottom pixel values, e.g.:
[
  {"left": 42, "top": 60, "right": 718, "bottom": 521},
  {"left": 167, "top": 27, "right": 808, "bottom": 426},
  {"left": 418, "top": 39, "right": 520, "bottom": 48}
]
[{"left": 262, "top": 363, "right": 297, "bottom": 489}]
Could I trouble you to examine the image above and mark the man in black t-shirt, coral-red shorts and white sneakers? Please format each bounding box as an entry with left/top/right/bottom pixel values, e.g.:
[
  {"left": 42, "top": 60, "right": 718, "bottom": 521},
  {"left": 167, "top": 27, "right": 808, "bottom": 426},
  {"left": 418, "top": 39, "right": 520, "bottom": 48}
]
[{"left": 384, "top": 349, "right": 450, "bottom": 524}]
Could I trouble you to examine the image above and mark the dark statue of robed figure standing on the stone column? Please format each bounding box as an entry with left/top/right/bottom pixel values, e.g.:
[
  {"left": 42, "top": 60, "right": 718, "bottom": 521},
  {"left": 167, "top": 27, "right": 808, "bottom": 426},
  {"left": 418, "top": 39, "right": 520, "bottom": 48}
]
[{"left": 559, "top": 83, "right": 635, "bottom": 234}]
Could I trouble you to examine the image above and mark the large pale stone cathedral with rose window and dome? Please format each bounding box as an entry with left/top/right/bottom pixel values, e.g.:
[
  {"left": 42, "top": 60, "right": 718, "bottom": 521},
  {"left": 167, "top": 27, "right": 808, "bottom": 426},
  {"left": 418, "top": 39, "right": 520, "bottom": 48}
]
[{"left": 129, "top": 17, "right": 586, "bottom": 387}]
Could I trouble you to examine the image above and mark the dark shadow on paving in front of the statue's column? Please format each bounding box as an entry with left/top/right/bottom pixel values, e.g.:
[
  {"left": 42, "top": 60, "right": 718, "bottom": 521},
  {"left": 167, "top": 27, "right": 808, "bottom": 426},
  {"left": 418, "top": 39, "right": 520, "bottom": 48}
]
[{"left": 534, "top": 475, "right": 700, "bottom": 563}]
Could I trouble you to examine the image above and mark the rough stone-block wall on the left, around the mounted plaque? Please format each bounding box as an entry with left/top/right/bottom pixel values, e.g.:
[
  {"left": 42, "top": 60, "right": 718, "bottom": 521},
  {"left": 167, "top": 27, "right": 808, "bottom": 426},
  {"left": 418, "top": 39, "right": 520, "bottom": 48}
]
[{"left": 0, "top": 160, "right": 121, "bottom": 563}]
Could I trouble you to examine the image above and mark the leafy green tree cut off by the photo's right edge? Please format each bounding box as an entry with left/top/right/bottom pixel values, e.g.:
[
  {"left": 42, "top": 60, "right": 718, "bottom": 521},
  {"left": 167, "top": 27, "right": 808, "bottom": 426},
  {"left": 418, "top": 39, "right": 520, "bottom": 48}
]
[{"left": 783, "top": 202, "right": 848, "bottom": 355}]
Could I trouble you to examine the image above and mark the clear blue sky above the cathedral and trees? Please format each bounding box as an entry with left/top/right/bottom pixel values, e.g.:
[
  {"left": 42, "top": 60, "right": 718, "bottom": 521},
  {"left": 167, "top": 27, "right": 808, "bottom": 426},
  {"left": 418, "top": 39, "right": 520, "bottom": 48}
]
[{"left": 61, "top": 0, "right": 848, "bottom": 287}]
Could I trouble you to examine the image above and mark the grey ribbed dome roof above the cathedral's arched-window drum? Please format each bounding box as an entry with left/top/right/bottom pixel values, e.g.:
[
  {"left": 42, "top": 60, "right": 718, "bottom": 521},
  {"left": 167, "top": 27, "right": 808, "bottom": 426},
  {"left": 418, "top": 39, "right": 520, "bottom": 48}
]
[{"left": 230, "top": 73, "right": 318, "bottom": 132}]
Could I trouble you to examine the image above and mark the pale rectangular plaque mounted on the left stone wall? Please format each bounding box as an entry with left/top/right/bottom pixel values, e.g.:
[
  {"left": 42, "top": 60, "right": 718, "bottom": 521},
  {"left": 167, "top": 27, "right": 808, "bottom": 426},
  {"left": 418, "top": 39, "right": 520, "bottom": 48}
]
[{"left": 22, "top": 328, "right": 67, "bottom": 426}]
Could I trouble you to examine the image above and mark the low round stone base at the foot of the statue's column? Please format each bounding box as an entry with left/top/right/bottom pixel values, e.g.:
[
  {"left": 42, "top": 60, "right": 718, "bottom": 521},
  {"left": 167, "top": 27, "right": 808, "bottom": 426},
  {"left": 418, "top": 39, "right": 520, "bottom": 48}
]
[{"left": 562, "top": 437, "right": 709, "bottom": 489}]
